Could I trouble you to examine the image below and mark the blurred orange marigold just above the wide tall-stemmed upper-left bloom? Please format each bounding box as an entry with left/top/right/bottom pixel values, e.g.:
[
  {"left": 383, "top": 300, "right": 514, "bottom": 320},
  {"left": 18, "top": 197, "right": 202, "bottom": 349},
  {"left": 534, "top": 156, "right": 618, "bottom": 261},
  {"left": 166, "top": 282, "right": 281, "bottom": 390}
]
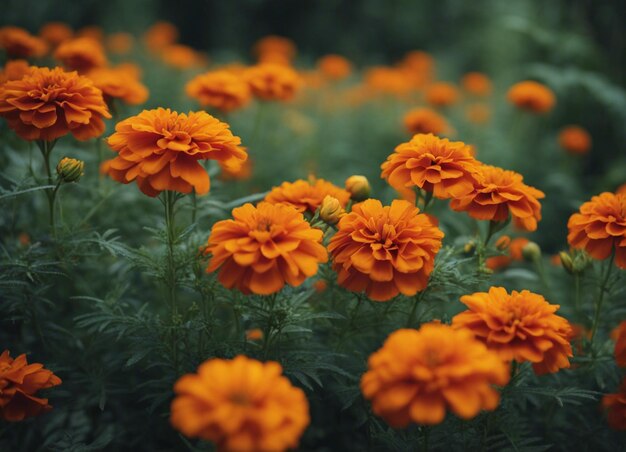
[{"left": 185, "top": 70, "right": 252, "bottom": 112}]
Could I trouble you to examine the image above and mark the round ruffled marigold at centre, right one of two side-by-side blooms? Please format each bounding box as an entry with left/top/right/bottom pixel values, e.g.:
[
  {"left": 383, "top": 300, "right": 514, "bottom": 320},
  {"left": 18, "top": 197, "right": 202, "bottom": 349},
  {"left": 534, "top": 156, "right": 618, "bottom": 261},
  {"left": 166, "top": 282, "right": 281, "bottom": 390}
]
[{"left": 328, "top": 199, "right": 443, "bottom": 301}]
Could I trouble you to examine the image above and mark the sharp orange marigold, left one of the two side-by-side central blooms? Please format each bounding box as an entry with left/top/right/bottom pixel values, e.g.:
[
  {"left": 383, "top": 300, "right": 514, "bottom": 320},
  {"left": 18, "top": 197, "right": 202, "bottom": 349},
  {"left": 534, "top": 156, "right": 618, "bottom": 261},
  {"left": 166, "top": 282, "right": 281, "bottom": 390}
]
[{"left": 204, "top": 202, "right": 328, "bottom": 295}]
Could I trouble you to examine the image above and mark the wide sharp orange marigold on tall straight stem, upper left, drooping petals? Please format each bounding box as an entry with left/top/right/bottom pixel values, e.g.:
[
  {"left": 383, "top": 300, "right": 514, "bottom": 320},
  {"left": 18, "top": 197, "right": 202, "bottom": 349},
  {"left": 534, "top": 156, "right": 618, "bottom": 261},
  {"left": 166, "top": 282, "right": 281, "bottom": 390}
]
[{"left": 107, "top": 108, "right": 247, "bottom": 196}]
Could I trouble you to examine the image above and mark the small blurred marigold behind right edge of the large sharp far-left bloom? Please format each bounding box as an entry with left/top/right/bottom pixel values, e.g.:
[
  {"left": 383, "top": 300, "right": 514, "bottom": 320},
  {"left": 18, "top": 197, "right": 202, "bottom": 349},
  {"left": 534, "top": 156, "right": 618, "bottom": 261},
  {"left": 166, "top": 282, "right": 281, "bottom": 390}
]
[{"left": 87, "top": 66, "right": 148, "bottom": 105}]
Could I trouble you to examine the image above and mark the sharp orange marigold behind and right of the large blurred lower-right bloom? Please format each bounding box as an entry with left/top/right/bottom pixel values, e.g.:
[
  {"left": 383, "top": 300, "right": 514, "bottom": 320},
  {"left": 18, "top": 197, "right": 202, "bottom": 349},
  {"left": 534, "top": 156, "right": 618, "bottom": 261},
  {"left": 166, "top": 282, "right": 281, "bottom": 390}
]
[{"left": 452, "top": 287, "right": 573, "bottom": 375}]
